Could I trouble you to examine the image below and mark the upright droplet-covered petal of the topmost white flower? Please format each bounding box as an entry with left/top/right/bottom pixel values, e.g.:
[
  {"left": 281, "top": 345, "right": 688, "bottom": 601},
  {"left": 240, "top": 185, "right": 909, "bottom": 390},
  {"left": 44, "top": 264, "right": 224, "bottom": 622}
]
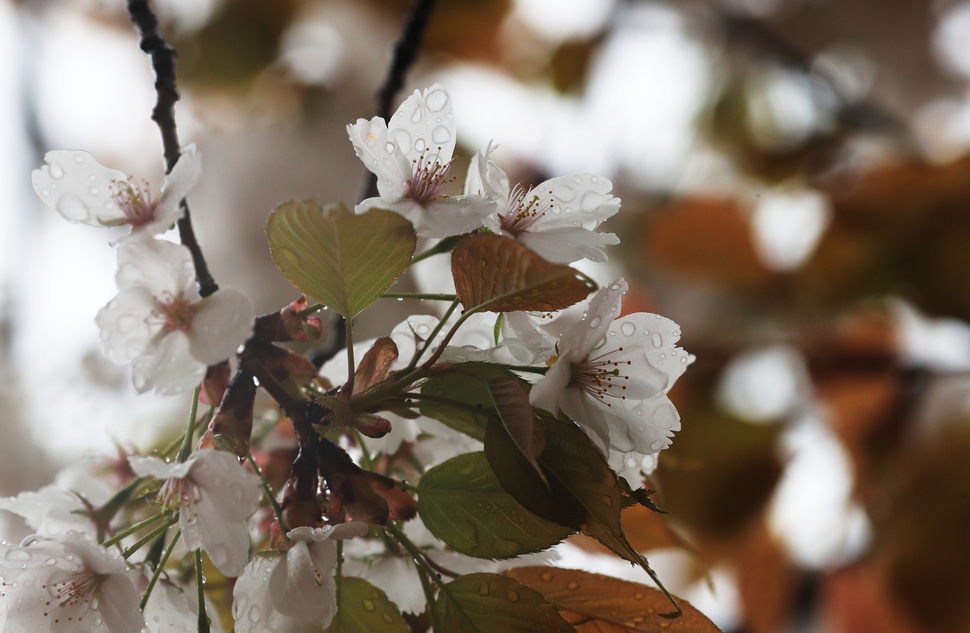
[{"left": 387, "top": 84, "right": 456, "bottom": 165}]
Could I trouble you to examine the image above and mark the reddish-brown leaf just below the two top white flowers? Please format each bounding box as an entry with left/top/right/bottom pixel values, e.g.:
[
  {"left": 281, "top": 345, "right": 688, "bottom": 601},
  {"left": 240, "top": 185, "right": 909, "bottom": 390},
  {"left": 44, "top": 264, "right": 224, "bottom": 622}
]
[{"left": 451, "top": 233, "right": 596, "bottom": 312}]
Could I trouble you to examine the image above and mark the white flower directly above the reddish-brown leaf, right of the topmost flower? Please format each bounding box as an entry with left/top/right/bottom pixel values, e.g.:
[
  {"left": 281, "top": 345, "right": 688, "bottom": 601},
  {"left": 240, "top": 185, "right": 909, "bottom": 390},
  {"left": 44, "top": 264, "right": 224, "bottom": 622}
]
[{"left": 465, "top": 145, "right": 620, "bottom": 264}]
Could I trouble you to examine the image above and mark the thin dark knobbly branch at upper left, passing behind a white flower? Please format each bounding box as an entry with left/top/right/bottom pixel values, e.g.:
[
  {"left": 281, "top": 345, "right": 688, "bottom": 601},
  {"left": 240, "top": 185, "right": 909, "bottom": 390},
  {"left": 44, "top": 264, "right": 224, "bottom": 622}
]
[{"left": 128, "top": 0, "right": 219, "bottom": 297}]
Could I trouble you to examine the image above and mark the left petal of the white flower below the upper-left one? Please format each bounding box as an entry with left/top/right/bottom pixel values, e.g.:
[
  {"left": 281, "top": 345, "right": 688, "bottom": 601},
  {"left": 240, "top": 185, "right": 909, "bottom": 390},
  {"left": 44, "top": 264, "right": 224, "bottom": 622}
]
[{"left": 94, "top": 287, "right": 157, "bottom": 363}]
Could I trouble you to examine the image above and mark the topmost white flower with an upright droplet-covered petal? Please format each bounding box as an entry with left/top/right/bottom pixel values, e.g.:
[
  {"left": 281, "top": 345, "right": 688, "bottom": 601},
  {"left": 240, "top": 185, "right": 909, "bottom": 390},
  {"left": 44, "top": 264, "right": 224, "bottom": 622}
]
[{"left": 347, "top": 84, "right": 494, "bottom": 238}]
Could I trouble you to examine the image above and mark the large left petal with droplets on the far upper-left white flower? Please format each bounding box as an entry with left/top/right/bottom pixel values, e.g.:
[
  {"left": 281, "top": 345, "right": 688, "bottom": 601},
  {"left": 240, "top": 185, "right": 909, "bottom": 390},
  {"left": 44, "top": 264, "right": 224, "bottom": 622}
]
[{"left": 30, "top": 150, "right": 127, "bottom": 226}]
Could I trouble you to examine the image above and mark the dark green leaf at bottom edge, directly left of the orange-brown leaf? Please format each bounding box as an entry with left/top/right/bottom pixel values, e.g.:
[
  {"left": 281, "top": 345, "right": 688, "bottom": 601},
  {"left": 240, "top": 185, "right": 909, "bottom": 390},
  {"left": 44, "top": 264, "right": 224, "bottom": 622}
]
[{"left": 433, "top": 574, "right": 576, "bottom": 633}]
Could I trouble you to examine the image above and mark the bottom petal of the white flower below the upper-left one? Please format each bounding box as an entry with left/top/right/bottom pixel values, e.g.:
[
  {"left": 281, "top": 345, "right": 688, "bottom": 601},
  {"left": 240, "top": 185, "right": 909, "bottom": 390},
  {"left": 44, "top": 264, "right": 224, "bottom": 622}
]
[{"left": 131, "top": 332, "right": 206, "bottom": 396}]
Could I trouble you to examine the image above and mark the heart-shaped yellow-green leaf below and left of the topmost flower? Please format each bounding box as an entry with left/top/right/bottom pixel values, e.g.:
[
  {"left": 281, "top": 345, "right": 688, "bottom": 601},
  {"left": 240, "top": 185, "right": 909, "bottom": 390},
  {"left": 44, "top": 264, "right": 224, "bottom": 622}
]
[{"left": 266, "top": 200, "right": 417, "bottom": 320}]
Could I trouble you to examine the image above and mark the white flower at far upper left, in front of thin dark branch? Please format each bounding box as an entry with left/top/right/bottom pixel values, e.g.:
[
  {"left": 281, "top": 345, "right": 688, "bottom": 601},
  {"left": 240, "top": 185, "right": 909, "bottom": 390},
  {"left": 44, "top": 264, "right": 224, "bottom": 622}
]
[{"left": 30, "top": 145, "right": 202, "bottom": 236}]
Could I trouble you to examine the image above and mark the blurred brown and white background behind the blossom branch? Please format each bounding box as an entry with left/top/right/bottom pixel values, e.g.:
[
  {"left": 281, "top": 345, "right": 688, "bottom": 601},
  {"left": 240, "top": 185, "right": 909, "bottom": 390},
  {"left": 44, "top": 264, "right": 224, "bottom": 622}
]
[{"left": 0, "top": 0, "right": 970, "bottom": 633}]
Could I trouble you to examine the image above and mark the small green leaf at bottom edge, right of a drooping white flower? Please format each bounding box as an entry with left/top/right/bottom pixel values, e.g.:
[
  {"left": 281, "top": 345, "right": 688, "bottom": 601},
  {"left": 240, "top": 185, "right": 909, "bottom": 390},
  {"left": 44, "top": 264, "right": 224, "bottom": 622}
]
[{"left": 327, "top": 576, "right": 410, "bottom": 633}]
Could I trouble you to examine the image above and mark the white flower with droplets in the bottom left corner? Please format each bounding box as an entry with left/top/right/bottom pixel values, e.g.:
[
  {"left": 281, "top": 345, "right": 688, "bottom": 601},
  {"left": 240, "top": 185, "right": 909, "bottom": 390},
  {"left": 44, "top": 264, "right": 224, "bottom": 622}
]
[{"left": 0, "top": 533, "right": 145, "bottom": 633}]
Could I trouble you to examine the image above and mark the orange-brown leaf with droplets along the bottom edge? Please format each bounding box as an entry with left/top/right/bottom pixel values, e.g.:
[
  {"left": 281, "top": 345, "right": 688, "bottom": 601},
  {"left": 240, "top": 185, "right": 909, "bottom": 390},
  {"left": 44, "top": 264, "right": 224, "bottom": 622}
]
[{"left": 504, "top": 567, "right": 719, "bottom": 633}]
